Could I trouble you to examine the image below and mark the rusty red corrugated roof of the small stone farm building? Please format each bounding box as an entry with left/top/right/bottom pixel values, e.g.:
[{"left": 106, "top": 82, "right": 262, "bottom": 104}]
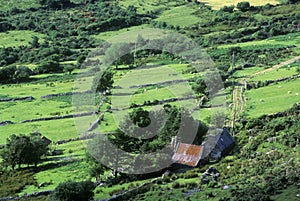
[{"left": 172, "top": 143, "right": 203, "bottom": 167}]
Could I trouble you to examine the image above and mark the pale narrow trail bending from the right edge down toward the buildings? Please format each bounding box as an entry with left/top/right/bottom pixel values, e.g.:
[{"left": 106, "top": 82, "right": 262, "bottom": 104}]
[{"left": 230, "top": 56, "right": 300, "bottom": 130}]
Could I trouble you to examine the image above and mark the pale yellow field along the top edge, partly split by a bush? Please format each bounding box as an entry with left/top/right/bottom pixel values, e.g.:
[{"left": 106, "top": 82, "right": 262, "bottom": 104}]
[{"left": 198, "top": 0, "right": 279, "bottom": 10}]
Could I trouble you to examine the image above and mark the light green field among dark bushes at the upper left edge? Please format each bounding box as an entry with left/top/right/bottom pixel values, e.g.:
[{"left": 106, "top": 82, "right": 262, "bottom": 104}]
[{"left": 0, "top": 30, "right": 44, "bottom": 47}]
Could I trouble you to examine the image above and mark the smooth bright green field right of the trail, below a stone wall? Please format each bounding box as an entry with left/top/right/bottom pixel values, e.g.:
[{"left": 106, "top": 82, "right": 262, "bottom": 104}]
[{"left": 245, "top": 79, "right": 300, "bottom": 118}]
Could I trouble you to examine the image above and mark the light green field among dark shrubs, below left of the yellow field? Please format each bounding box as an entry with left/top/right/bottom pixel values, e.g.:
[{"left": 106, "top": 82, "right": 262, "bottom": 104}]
[{"left": 156, "top": 5, "right": 200, "bottom": 27}]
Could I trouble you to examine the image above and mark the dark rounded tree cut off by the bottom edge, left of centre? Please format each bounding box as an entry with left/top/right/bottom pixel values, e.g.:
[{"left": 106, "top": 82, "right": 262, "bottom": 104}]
[{"left": 53, "top": 181, "right": 96, "bottom": 201}]
